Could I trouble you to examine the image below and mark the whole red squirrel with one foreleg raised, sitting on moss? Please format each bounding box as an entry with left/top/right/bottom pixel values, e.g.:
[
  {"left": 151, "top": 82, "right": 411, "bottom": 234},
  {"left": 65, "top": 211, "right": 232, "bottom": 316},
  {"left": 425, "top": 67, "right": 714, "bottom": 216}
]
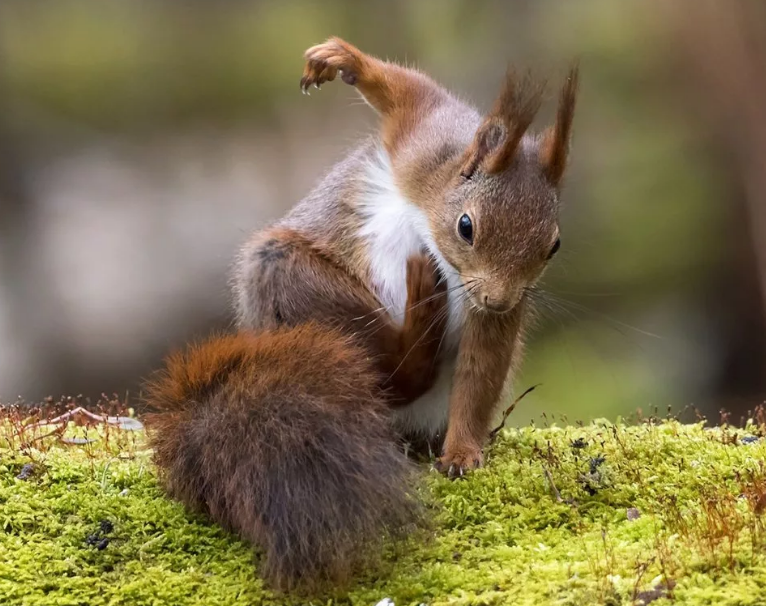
[{"left": 146, "top": 37, "right": 578, "bottom": 590}]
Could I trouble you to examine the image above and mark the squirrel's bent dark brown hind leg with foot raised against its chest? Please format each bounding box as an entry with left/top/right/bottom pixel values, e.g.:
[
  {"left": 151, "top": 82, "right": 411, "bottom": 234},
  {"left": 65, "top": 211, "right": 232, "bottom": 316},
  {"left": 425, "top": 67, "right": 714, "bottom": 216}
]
[{"left": 234, "top": 228, "right": 445, "bottom": 405}]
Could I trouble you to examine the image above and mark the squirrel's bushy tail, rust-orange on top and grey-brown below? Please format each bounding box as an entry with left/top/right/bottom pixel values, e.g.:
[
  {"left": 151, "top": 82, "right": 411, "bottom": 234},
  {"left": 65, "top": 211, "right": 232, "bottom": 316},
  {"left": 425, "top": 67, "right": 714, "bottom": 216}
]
[{"left": 147, "top": 325, "right": 420, "bottom": 589}]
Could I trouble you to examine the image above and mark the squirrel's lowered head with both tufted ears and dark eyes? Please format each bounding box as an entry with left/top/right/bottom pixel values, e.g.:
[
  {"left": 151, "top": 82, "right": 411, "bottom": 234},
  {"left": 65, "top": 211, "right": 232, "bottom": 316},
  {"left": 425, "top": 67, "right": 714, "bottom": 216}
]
[{"left": 430, "top": 67, "right": 578, "bottom": 312}]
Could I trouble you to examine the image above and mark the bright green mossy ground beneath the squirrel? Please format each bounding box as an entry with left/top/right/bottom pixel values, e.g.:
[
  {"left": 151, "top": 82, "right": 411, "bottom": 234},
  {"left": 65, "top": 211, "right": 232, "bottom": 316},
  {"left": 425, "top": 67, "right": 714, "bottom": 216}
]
[{"left": 0, "top": 414, "right": 766, "bottom": 606}]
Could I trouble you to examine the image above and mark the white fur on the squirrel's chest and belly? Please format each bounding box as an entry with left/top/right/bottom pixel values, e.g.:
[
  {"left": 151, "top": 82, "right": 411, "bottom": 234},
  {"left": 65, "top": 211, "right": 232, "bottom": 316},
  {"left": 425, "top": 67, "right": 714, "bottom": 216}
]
[{"left": 360, "top": 150, "right": 465, "bottom": 434}]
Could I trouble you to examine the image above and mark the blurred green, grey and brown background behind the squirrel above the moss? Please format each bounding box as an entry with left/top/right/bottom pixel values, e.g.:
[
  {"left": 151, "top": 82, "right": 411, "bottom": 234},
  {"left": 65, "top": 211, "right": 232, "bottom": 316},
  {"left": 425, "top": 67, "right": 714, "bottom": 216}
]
[{"left": 0, "top": 0, "right": 766, "bottom": 423}]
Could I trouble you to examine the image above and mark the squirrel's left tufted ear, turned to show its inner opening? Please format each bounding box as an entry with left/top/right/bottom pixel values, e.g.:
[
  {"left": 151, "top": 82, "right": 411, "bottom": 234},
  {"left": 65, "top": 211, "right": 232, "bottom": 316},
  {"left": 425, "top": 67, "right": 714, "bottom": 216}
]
[{"left": 460, "top": 68, "right": 544, "bottom": 178}]
